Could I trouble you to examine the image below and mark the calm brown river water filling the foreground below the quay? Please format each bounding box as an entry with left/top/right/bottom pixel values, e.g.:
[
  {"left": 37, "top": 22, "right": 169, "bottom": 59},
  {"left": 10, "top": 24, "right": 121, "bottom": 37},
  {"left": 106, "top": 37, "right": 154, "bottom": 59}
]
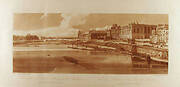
[{"left": 13, "top": 44, "right": 167, "bottom": 74}]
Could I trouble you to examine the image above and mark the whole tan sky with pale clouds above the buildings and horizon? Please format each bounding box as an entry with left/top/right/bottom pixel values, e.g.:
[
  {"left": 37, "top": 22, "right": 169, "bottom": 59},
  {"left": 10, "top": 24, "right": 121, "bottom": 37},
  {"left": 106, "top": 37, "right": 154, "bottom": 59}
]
[{"left": 13, "top": 13, "right": 168, "bottom": 37}]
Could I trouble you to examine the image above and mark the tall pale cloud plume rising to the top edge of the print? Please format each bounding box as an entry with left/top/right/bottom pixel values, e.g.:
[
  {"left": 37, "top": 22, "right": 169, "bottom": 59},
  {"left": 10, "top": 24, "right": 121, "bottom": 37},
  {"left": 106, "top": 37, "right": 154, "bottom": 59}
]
[{"left": 44, "top": 13, "right": 88, "bottom": 37}]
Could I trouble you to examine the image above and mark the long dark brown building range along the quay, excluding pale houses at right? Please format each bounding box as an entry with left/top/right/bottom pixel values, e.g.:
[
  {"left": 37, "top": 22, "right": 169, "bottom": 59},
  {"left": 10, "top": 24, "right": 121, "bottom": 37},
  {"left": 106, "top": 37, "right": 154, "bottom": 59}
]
[{"left": 78, "top": 23, "right": 157, "bottom": 40}]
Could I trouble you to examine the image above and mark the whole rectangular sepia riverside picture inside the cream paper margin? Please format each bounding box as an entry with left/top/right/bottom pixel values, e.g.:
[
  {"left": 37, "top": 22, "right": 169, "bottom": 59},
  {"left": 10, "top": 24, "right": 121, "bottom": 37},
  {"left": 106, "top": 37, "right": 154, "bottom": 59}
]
[{"left": 13, "top": 13, "right": 169, "bottom": 74}]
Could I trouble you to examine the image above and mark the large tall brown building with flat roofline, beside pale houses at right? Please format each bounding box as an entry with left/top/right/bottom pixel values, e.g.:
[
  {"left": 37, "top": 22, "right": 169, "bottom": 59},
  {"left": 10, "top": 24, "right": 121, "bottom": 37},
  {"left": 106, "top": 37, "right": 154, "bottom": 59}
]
[{"left": 119, "top": 23, "right": 157, "bottom": 40}]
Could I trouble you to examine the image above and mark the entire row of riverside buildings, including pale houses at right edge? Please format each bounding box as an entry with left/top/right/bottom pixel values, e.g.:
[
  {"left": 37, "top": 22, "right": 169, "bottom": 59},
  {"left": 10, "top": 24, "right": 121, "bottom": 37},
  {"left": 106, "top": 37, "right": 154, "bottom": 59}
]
[{"left": 78, "top": 23, "right": 168, "bottom": 44}]
